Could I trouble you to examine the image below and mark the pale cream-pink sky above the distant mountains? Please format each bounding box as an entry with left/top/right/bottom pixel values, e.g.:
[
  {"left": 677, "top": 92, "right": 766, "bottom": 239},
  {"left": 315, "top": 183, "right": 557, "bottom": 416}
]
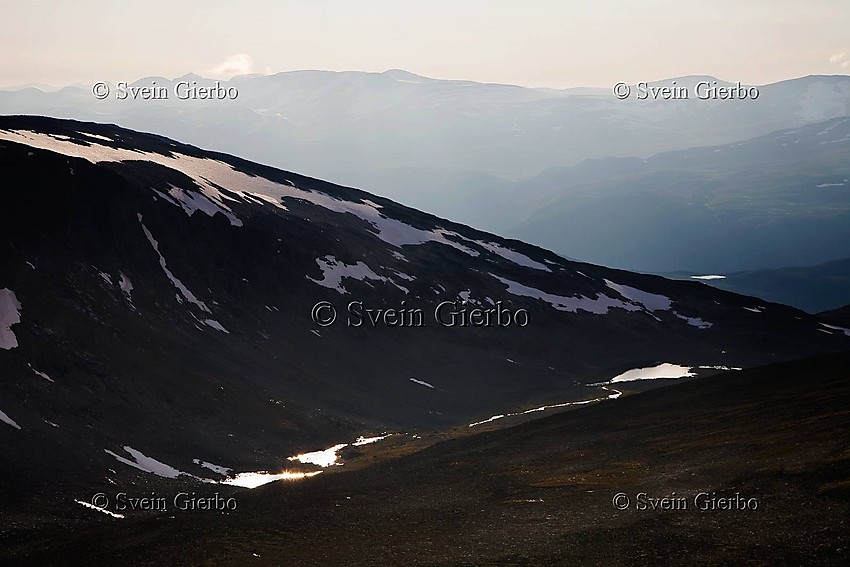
[{"left": 0, "top": 0, "right": 850, "bottom": 88}]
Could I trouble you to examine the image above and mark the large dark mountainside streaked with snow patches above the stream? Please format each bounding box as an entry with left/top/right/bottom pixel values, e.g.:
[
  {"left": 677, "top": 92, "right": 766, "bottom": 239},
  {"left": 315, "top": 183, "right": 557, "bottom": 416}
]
[{"left": 0, "top": 116, "right": 850, "bottom": 537}]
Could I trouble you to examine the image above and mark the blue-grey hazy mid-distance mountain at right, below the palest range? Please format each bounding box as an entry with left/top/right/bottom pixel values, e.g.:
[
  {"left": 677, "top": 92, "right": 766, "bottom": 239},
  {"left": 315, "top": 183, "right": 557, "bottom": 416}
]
[{"left": 506, "top": 117, "right": 850, "bottom": 274}]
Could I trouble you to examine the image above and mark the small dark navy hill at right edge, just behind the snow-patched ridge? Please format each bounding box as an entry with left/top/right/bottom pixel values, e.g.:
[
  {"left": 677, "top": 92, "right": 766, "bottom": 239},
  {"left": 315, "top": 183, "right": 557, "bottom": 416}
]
[{"left": 659, "top": 258, "right": 850, "bottom": 313}]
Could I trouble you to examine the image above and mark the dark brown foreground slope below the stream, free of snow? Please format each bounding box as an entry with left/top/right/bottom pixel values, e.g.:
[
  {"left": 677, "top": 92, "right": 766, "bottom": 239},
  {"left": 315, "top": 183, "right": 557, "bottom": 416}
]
[{"left": 4, "top": 354, "right": 850, "bottom": 565}]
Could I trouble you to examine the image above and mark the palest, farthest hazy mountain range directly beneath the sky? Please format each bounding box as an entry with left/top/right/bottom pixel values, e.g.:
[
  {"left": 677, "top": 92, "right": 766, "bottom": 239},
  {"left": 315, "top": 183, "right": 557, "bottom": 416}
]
[{"left": 0, "top": 70, "right": 850, "bottom": 197}]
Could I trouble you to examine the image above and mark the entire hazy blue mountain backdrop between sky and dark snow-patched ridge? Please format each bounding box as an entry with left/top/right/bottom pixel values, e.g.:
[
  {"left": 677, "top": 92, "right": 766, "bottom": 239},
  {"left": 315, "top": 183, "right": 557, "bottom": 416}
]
[{"left": 0, "top": 70, "right": 850, "bottom": 280}]
